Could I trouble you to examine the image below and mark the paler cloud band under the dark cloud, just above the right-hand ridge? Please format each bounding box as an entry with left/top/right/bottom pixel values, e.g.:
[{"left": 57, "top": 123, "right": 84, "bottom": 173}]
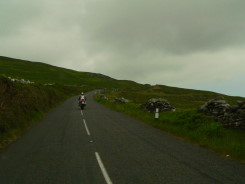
[{"left": 88, "top": 48, "right": 245, "bottom": 89}]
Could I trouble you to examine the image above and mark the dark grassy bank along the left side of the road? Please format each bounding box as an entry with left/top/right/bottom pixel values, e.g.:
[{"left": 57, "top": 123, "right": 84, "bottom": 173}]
[{"left": 0, "top": 77, "right": 92, "bottom": 148}]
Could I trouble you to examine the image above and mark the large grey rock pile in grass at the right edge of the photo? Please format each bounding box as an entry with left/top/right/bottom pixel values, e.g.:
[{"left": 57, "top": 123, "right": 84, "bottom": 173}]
[{"left": 198, "top": 99, "right": 245, "bottom": 130}]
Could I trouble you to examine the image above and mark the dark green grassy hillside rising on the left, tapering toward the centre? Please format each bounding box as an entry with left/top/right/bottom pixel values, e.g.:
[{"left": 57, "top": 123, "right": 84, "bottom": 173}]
[{"left": 0, "top": 56, "right": 138, "bottom": 88}]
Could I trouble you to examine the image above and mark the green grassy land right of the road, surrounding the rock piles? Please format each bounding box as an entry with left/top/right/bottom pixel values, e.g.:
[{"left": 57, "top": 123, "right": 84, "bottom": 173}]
[{"left": 96, "top": 89, "right": 245, "bottom": 161}]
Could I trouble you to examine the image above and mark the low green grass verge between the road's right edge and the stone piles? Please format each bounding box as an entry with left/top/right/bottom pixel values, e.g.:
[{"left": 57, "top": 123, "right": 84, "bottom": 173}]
[{"left": 95, "top": 96, "right": 245, "bottom": 162}]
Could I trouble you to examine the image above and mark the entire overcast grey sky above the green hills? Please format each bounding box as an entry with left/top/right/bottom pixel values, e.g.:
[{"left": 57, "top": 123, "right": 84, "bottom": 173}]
[{"left": 0, "top": 0, "right": 245, "bottom": 96}]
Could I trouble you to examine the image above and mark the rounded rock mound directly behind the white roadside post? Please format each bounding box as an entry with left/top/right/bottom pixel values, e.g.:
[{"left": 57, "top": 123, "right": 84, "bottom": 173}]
[{"left": 140, "top": 98, "right": 175, "bottom": 112}]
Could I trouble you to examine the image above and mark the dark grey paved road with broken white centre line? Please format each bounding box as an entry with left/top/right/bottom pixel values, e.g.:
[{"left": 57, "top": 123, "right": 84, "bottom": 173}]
[{"left": 0, "top": 93, "right": 245, "bottom": 184}]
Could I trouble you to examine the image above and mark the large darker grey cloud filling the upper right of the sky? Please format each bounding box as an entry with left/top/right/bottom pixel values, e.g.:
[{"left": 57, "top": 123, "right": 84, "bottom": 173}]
[{"left": 82, "top": 0, "right": 245, "bottom": 54}]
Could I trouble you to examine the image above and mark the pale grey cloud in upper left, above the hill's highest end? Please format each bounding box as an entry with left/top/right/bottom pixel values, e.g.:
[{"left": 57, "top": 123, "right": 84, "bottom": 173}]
[{"left": 0, "top": 0, "right": 87, "bottom": 64}]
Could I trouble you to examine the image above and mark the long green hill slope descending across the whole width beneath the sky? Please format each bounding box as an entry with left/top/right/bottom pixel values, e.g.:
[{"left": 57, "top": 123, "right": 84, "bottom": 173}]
[{"left": 0, "top": 56, "right": 244, "bottom": 108}]
